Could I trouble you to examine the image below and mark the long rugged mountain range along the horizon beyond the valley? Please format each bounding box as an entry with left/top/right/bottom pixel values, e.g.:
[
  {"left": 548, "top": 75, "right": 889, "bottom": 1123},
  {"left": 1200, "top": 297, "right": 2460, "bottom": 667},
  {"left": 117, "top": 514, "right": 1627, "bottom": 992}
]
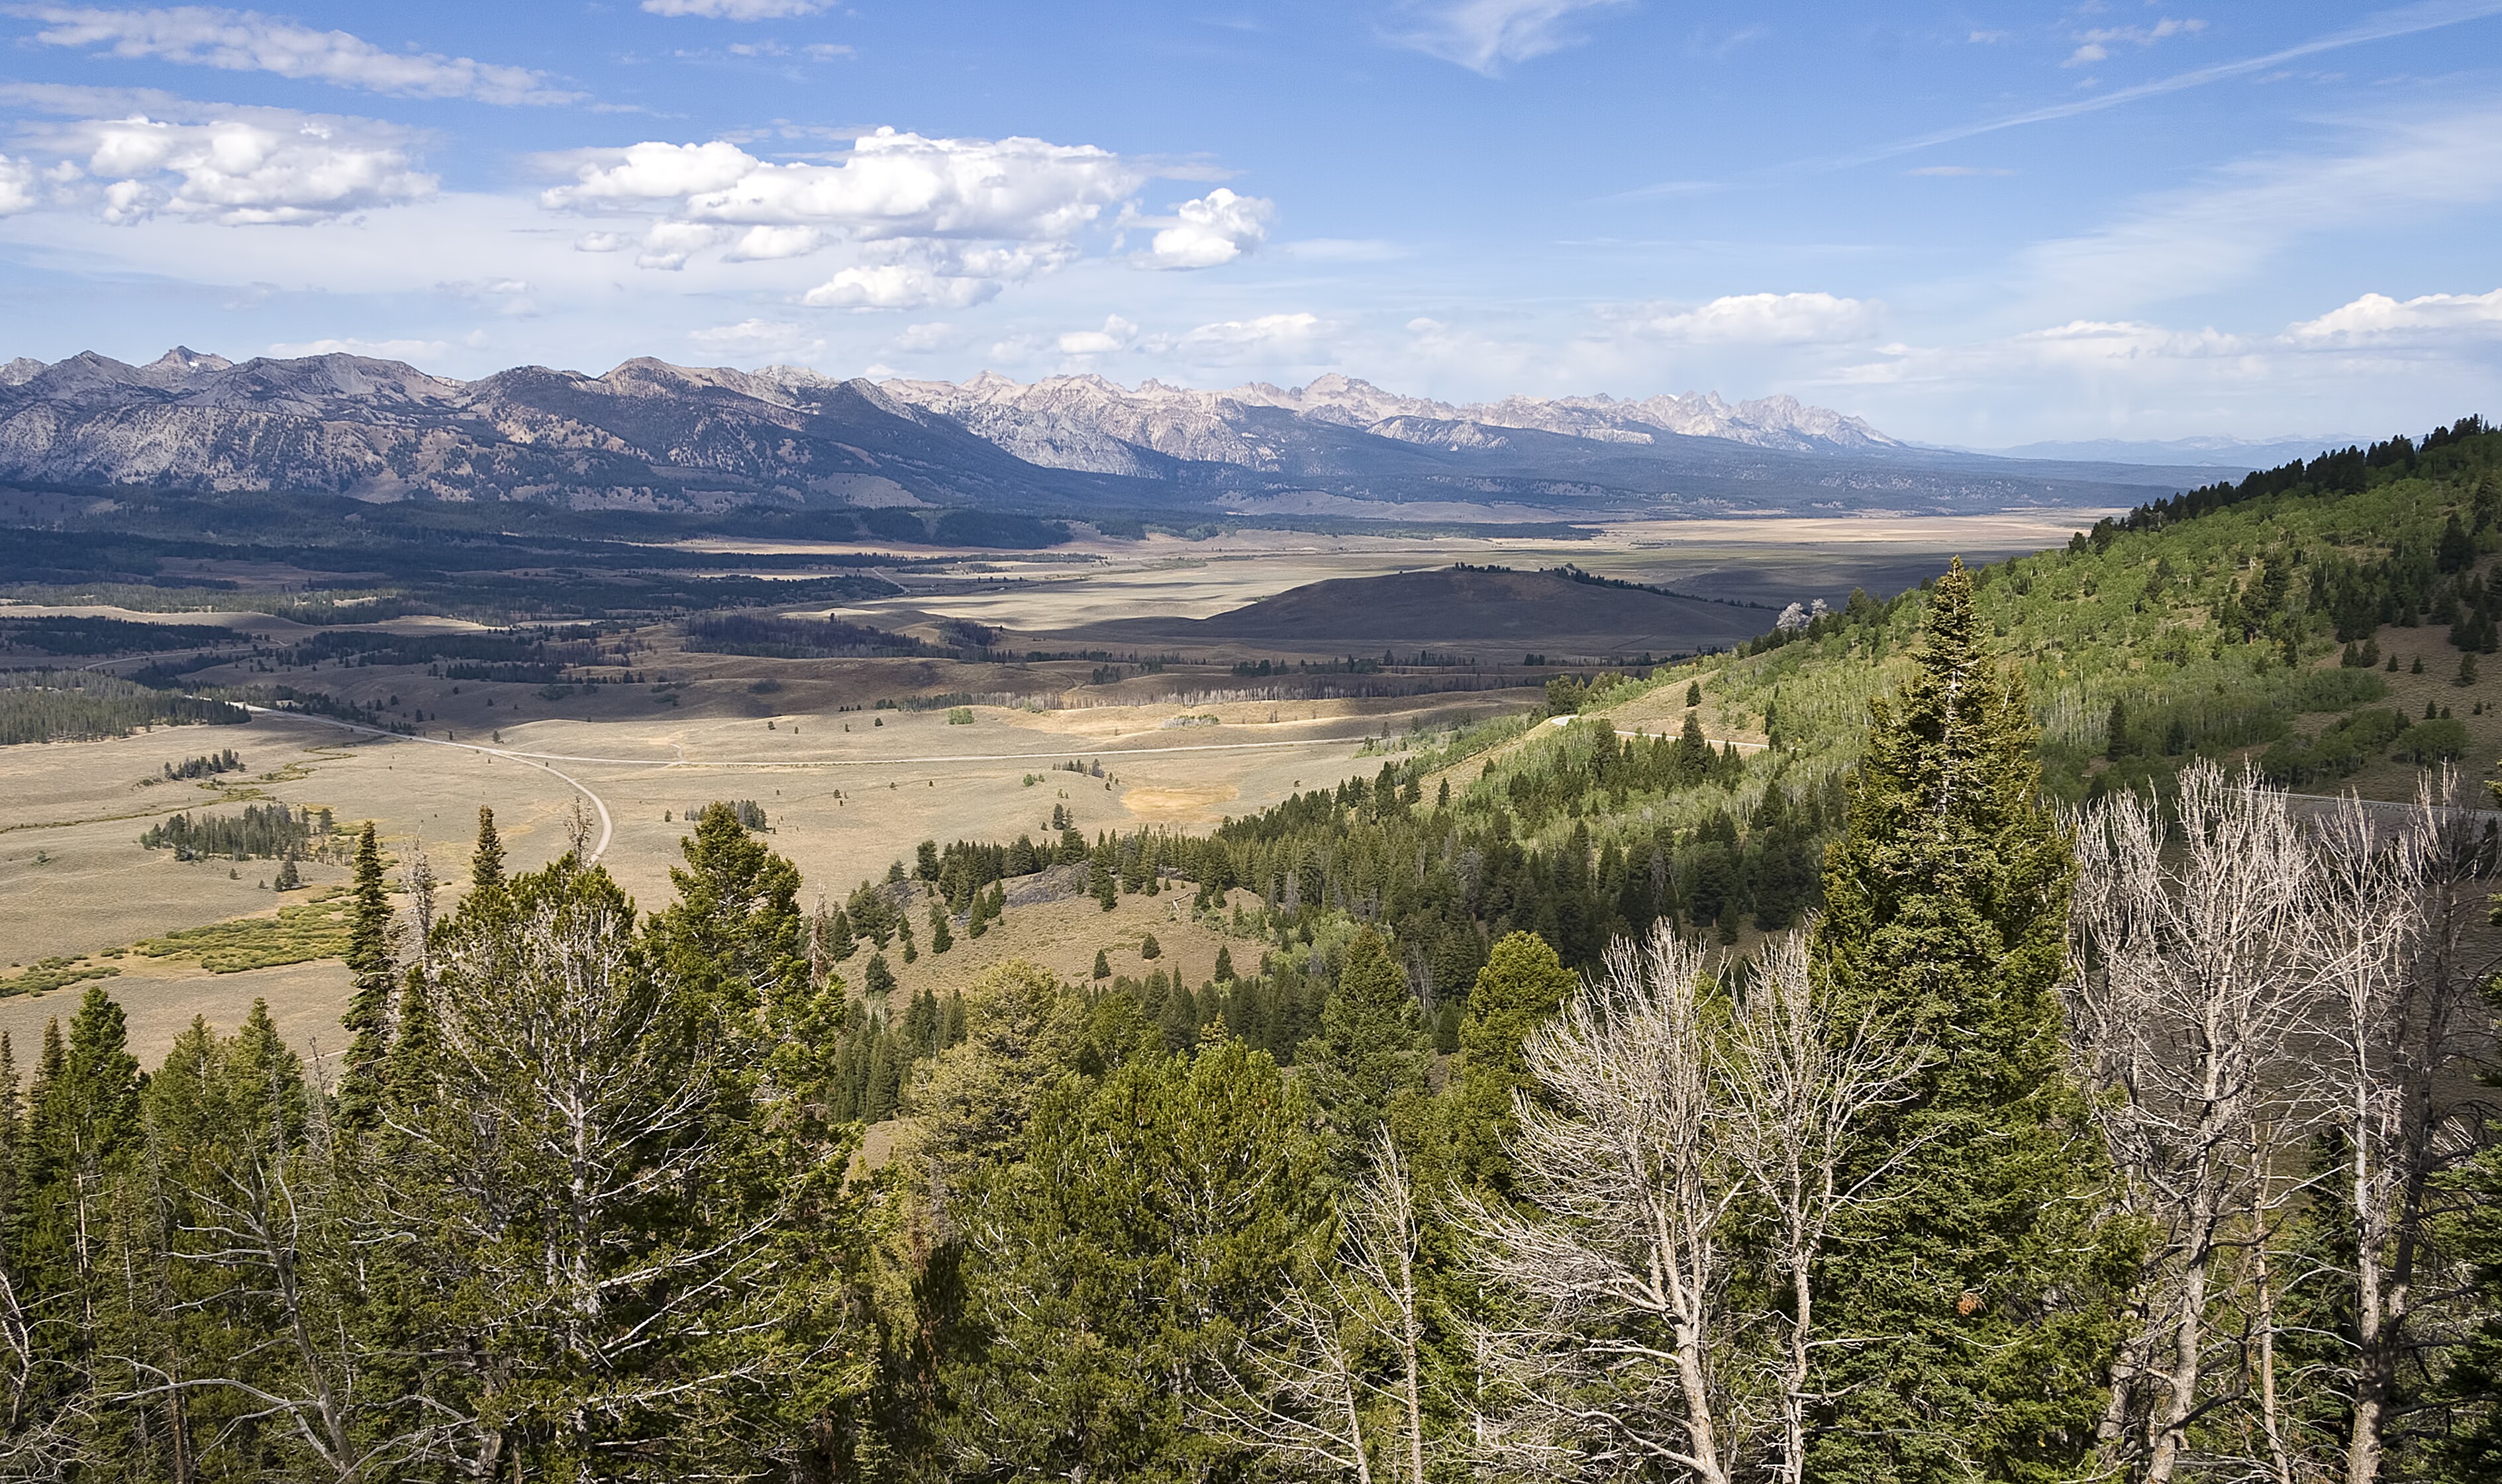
[{"left": 0, "top": 348, "right": 2247, "bottom": 523}]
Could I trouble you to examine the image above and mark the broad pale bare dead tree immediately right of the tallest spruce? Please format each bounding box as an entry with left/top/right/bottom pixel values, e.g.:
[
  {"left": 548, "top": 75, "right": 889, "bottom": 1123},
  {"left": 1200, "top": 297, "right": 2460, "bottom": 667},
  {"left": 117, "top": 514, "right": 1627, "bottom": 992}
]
[{"left": 2067, "top": 764, "right": 2315, "bottom": 1484}]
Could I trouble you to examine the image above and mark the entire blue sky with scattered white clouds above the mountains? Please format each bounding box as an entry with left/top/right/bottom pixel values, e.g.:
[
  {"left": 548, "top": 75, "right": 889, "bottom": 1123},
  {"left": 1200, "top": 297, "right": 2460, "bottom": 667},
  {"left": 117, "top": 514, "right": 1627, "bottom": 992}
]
[{"left": 0, "top": 0, "right": 2502, "bottom": 446}]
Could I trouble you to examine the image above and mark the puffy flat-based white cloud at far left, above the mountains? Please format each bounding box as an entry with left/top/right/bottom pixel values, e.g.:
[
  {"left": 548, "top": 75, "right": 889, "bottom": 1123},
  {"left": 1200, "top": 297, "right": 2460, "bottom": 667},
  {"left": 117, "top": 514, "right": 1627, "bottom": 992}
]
[{"left": 32, "top": 108, "right": 435, "bottom": 225}]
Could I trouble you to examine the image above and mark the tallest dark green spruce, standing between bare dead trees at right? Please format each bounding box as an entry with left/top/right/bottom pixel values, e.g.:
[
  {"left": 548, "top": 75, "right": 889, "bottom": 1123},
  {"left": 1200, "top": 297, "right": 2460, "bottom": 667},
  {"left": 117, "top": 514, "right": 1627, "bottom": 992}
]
[{"left": 1809, "top": 561, "right": 2129, "bottom": 1484}]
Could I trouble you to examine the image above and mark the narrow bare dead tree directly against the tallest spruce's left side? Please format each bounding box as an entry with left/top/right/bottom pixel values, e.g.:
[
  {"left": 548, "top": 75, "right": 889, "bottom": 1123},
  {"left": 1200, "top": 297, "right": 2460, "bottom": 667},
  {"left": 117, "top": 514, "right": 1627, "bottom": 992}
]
[{"left": 1721, "top": 934, "right": 1919, "bottom": 1484}]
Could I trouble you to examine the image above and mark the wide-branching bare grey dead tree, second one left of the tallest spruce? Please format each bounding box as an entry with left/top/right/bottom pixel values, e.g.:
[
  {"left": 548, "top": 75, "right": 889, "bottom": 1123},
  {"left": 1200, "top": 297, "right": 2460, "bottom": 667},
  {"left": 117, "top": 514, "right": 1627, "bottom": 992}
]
[{"left": 1459, "top": 923, "right": 1752, "bottom": 1484}]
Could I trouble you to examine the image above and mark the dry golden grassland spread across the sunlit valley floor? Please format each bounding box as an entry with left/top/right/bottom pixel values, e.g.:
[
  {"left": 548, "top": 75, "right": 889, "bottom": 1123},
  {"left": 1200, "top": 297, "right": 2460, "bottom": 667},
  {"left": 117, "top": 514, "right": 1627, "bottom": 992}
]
[{"left": 0, "top": 511, "right": 2131, "bottom": 1059}]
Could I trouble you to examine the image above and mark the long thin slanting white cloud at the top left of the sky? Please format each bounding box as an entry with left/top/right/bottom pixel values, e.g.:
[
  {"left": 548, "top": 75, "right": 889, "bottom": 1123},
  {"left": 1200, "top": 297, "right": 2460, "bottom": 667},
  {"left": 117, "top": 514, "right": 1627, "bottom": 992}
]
[{"left": 10, "top": 5, "right": 580, "bottom": 103}]
